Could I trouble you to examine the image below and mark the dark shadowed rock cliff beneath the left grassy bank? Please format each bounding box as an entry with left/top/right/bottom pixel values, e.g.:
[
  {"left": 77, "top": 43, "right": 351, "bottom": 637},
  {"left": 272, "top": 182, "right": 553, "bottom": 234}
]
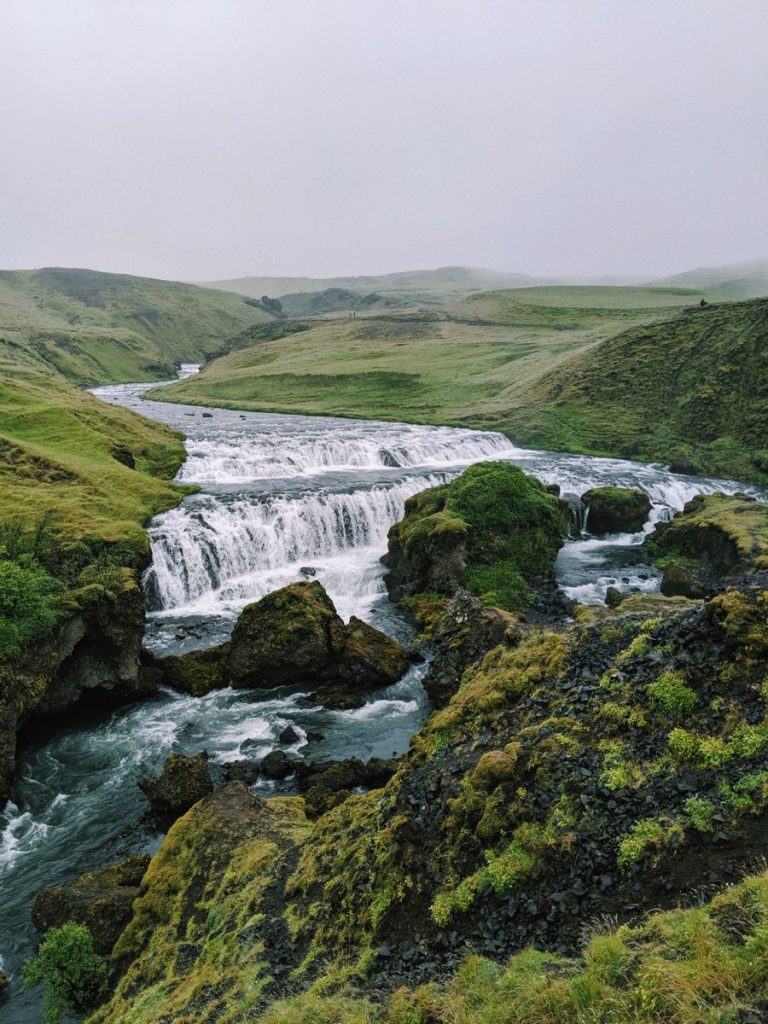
[{"left": 0, "top": 577, "right": 157, "bottom": 806}]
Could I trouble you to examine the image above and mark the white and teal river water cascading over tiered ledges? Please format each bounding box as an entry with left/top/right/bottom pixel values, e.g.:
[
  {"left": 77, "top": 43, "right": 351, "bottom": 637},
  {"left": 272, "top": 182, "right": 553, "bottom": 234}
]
[{"left": 0, "top": 367, "right": 766, "bottom": 1024}]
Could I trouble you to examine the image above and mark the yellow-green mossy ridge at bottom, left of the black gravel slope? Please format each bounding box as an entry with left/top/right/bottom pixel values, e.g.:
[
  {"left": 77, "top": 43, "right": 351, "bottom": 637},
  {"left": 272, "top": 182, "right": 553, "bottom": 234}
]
[{"left": 91, "top": 782, "right": 307, "bottom": 1024}]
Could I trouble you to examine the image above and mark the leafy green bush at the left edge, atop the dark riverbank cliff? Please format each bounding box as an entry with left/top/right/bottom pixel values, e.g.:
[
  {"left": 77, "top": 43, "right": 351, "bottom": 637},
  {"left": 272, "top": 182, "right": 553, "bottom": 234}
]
[{"left": 0, "top": 556, "right": 65, "bottom": 662}]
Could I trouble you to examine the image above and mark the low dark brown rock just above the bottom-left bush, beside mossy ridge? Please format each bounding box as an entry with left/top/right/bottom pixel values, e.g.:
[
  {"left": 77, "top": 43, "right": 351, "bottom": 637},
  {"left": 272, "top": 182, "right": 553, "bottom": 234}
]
[{"left": 32, "top": 854, "right": 150, "bottom": 954}]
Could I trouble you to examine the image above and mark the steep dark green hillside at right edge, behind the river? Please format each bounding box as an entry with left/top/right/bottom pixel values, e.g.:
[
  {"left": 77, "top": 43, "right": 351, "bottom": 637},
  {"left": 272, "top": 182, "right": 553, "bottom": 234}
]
[{"left": 509, "top": 299, "right": 768, "bottom": 481}]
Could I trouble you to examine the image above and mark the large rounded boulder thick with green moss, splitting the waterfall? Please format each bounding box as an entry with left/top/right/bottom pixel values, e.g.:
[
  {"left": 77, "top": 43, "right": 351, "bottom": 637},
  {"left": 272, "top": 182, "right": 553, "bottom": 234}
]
[{"left": 383, "top": 462, "right": 568, "bottom": 610}]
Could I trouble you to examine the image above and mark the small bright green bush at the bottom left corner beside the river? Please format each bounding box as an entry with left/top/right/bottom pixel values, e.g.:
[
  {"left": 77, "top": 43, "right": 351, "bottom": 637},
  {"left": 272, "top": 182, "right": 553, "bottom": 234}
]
[{"left": 22, "top": 922, "right": 106, "bottom": 1024}]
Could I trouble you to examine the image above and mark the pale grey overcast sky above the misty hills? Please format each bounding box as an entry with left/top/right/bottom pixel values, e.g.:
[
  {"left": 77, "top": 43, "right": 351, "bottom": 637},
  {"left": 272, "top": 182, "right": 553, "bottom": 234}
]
[{"left": 0, "top": 0, "right": 768, "bottom": 280}]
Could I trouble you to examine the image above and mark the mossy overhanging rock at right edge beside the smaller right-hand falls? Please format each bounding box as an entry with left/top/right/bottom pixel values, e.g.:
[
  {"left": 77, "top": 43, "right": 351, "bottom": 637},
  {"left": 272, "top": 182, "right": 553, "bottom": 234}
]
[{"left": 646, "top": 495, "right": 768, "bottom": 598}]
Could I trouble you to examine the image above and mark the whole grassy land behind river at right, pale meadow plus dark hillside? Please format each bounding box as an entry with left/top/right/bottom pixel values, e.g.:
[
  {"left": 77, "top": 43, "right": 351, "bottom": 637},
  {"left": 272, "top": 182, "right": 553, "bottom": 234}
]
[{"left": 157, "top": 286, "right": 768, "bottom": 482}]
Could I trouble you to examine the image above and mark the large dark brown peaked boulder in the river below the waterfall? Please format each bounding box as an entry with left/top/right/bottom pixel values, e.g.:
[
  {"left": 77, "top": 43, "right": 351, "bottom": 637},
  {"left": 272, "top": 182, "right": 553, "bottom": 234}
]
[{"left": 156, "top": 581, "right": 409, "bottom": 707}]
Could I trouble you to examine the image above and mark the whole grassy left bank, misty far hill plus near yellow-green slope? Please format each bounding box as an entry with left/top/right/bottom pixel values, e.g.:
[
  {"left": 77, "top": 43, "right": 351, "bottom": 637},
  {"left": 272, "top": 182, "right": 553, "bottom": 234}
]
[{"left": 0, "top": 268, "right": 271, "bottom": 549}]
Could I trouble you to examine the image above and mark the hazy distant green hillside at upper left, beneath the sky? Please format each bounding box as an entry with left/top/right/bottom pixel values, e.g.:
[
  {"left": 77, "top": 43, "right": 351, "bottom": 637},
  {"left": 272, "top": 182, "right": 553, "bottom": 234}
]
[{"left": 0, "top": 267, "right": 270, "bottom": 385}]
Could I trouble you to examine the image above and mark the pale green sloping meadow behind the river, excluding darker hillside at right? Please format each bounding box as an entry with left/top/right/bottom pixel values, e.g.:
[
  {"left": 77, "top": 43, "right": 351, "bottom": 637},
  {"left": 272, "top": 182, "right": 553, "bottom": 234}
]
[{"left": 151, "top": 287, "right": 698, "bottom": 428}]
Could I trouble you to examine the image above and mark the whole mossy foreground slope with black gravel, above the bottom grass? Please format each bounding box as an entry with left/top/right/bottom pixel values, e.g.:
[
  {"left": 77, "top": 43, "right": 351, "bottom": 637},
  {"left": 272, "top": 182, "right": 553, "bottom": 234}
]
[{"left": 78, "top": 575, "right": 768, "bottom": 1024}]
